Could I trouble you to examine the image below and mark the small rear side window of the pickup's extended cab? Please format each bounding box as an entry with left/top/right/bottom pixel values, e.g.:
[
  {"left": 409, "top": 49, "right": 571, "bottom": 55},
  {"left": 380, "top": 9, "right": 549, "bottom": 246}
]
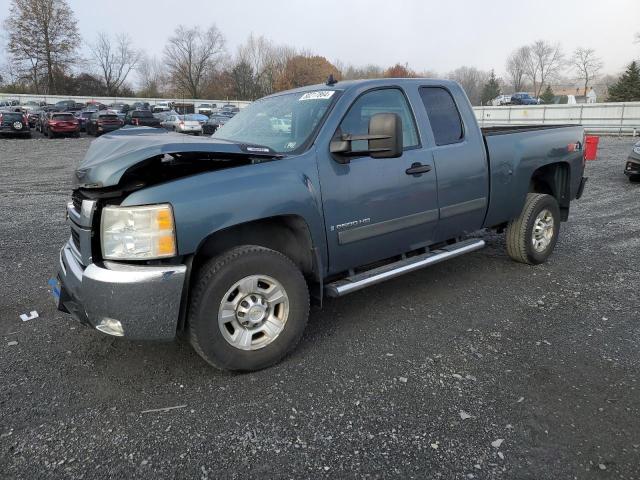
[{"left": 420, "top": 87, "right": 464, "bottom": 146}]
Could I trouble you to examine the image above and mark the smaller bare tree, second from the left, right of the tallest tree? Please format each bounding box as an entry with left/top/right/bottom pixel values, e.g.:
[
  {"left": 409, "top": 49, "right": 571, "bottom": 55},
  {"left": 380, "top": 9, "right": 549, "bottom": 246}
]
[{"left": 89, "top": 32, "right": 140, "bottom": 95}]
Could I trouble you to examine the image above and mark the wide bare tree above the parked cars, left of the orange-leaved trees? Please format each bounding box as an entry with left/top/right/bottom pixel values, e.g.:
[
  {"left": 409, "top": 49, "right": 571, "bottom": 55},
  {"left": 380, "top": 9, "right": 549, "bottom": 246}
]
[{"left": 164, "top": 25, "right": 225, "bottom": 98}]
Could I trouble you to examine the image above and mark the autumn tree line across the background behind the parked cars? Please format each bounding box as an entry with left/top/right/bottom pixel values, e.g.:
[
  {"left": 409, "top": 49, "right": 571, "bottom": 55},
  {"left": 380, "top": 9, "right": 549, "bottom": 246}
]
[{"left": 0, "top": 0, "right": 640, "bottom": 105}]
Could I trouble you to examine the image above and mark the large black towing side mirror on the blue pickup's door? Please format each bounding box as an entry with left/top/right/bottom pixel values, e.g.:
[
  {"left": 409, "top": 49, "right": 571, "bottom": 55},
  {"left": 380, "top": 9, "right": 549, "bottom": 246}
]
[{"left": 329, "top": 113, "right": 402, "bottom": 163}]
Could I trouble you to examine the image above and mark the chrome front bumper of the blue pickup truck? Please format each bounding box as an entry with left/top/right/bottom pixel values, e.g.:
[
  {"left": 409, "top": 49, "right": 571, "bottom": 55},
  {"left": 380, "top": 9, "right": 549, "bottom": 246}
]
[{"left": 52, "top": 241, "right": 187, "bottom": 340}]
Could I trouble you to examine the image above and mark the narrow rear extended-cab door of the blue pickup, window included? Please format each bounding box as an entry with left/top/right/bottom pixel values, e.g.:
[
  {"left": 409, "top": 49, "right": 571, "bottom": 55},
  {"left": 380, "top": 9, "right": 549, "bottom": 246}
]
[{"left": 419, "top": 86, "right": 489, "bottom": 241}]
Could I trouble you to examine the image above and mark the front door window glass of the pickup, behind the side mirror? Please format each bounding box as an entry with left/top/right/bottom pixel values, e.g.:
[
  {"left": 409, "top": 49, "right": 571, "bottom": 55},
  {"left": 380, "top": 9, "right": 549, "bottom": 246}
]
[{"left": 340, "top": 88, "right": 419, "bottom": 151}]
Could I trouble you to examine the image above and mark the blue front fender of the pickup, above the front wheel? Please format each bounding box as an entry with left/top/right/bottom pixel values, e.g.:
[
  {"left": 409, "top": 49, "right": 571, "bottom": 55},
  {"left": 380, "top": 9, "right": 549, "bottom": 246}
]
[{"left": 122, "top": 152, "right": 327, "bottom": 272}]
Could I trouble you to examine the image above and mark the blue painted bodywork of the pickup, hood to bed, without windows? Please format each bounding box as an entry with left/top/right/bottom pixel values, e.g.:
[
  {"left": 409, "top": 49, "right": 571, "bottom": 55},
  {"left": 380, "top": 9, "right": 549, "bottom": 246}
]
[{"left": 77, "top": 79, "right": 584, "bottom": 276}]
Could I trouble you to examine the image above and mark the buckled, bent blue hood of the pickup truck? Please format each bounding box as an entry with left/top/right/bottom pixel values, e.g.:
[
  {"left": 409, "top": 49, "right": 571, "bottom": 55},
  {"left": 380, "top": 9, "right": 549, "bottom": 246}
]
[{"left": 74, "top": 126, "right": 278, "bottom": 188}]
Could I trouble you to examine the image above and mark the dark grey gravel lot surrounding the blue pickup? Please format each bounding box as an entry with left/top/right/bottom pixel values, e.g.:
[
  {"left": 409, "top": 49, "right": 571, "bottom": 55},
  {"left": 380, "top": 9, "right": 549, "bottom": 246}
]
[{"left": 0, "top": 133, "right": 640, "bottom": 479}]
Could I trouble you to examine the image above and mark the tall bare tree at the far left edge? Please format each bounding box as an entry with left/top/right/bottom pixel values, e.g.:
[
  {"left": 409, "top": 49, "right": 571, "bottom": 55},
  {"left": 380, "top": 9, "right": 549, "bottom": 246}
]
[{"left": 4, "top": 0, "right": 80, "bottom": 93}]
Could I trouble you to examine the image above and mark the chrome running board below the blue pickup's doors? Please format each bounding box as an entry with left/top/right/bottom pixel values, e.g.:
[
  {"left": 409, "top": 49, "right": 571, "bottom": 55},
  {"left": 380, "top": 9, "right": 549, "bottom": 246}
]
[{"left": 325, "top": 238, "right": 484, "bottom": 297}]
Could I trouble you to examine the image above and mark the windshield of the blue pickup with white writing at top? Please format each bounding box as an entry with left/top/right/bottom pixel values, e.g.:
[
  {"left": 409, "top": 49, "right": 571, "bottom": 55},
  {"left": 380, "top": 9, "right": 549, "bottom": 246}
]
[{"left": 212, "top": 90, "right": 336, "bottom": 153}]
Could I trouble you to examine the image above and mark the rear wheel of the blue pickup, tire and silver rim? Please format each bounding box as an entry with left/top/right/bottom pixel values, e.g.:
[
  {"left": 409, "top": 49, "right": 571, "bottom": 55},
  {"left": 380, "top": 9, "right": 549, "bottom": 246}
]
[{"left": 506, "top": 193, "right": 560, "bottom": 265}]
